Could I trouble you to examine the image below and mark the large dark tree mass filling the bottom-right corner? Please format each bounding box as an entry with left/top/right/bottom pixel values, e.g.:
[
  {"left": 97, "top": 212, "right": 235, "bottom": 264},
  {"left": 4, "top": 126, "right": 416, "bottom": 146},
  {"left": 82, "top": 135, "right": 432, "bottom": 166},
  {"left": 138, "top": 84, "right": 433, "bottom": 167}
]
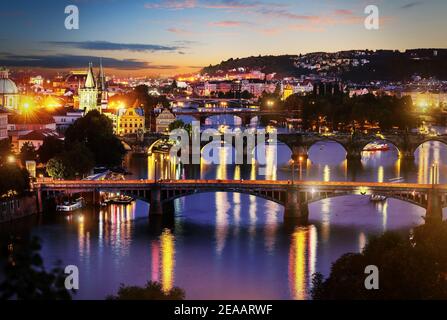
[{"left": 312, "top": 222, "right": 447, "bottom": 299}]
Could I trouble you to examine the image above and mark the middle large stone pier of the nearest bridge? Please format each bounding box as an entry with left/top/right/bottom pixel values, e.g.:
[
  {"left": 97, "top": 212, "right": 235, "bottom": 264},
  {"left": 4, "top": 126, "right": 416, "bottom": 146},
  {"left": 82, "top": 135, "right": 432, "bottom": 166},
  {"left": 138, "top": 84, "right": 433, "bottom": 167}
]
[{"left": 284, "top": 186, "right": 309, "bottom": 225}]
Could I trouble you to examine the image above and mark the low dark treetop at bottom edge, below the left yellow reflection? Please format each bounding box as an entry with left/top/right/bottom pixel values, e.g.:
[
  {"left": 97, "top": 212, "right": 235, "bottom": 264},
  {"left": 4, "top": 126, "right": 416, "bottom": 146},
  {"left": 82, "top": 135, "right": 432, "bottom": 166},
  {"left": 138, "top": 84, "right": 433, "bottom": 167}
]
[{"left": 107, "top": 281, "right": 185, "bottom": 300}]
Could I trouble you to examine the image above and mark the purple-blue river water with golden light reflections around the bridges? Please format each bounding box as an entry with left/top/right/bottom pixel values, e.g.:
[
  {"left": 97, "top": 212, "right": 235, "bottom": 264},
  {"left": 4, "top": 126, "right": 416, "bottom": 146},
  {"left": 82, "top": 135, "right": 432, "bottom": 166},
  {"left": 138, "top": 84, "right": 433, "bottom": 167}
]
[{"left": 10, "top": 142, "right": 447, "bottom": 299}]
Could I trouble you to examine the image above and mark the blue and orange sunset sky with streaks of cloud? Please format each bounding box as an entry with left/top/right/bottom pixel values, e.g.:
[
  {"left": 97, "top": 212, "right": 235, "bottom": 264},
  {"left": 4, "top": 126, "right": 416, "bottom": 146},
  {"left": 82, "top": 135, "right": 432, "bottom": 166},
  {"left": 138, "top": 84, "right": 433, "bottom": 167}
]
[{"left": 0, "top": 0, "right": 447, "bottom": 76}]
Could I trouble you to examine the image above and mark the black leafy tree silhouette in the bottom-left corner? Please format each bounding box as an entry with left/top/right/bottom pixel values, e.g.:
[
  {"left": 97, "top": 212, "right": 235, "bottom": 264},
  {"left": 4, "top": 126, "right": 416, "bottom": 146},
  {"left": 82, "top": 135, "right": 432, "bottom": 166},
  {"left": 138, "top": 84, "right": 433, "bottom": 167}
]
[{"left": 0, "top": 237, "right": 71, "bottom": 300}]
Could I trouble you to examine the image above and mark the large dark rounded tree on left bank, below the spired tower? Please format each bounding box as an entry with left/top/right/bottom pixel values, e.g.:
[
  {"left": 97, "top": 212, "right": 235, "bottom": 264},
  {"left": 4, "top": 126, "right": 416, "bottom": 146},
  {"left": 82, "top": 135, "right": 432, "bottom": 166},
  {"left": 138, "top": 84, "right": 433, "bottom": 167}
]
[{"left": 65, "top": 110, "right": 126, "bottom": 167}]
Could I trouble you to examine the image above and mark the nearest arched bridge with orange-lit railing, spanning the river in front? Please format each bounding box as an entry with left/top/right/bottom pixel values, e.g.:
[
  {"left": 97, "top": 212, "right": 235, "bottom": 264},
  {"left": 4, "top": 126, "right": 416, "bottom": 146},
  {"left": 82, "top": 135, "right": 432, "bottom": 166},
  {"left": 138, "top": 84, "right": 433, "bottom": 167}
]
[{"left": 33, "top": 180, "right": 447, "bottom": 224}]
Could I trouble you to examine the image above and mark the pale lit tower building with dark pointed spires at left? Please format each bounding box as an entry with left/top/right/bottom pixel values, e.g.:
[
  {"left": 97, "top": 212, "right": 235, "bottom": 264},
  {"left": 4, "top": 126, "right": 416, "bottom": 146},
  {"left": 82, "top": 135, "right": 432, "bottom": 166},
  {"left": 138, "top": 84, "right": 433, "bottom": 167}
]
[{"left": 78, "top": 63, "right": 108, "bottom": 113}]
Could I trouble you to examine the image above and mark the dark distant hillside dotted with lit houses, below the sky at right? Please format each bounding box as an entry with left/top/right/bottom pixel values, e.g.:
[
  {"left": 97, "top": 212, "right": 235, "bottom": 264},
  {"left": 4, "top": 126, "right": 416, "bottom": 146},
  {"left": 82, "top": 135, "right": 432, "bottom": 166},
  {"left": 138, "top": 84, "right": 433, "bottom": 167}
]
[{"left": 201, "top": 49, "right": 447, "bottom": 81}]
